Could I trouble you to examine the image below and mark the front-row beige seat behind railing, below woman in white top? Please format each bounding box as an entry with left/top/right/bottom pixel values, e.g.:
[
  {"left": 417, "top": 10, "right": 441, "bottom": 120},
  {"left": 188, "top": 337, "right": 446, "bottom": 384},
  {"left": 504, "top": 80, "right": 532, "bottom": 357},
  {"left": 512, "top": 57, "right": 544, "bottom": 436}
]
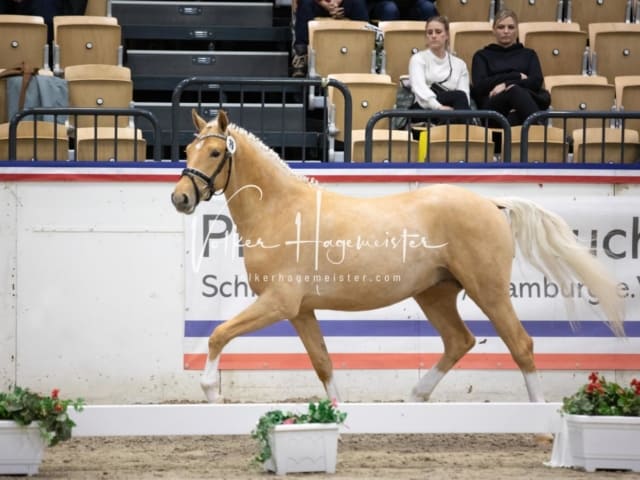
[{"left": 418, "top": 124, "right": 494, "bottom": 163}]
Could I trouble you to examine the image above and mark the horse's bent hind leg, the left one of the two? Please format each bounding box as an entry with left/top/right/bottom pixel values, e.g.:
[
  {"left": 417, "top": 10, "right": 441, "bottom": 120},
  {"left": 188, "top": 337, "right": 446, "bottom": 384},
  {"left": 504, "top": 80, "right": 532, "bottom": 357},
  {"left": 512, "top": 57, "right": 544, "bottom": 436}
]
[{"left": 411, "top": 281, "right": 475, "bottom": 402}]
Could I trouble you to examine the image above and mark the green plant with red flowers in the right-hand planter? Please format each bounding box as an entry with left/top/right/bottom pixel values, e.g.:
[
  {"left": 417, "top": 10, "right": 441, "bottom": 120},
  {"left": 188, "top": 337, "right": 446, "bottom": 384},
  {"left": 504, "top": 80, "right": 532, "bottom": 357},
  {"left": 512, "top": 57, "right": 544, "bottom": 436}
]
[{"left": 562, "top": 372, "right": 640, "bottom": 417}]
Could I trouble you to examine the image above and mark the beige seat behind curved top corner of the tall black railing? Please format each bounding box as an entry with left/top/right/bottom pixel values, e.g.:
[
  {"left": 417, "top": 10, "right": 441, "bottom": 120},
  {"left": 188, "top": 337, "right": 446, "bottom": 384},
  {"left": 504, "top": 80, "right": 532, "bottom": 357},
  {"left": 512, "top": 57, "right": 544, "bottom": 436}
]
[{"left": 328, "top": 73, "right": 397, "bottom": 141}]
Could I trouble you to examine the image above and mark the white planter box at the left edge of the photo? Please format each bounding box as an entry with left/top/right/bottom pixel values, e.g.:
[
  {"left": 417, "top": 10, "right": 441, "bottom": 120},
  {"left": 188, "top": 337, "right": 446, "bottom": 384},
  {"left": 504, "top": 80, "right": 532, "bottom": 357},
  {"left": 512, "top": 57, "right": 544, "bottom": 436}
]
[{"left": 0, "top": 420, "right": 45, "bottom": 475}]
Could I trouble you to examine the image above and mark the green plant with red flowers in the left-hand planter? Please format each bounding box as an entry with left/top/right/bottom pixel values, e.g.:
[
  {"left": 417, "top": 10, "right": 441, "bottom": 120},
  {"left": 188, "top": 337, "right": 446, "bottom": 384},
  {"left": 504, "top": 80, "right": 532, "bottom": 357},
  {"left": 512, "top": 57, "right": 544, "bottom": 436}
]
[{"left": 0, "top": 386, "right": 84, "bottom": 446}]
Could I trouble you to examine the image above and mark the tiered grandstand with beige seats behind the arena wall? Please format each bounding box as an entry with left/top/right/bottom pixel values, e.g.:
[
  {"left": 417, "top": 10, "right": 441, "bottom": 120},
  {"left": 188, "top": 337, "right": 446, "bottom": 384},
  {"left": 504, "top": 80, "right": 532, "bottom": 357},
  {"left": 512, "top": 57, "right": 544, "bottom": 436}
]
[{"left": 0, "top": 0, "right": 640, "bottom": 163}]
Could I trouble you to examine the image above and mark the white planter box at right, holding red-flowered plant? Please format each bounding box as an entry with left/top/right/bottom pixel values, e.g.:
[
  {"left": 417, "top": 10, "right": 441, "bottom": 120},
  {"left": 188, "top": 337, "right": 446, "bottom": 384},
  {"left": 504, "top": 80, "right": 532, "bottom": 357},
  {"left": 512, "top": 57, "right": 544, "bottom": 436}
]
[{"left": 565, "top": 415, "right": 640, "bottom": 472}]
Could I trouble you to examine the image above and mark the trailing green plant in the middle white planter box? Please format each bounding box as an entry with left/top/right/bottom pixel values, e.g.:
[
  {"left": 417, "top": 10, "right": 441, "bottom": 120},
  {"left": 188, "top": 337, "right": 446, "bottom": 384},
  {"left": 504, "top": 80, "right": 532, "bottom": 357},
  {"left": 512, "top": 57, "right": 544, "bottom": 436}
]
[{"left": 251, "top": 399, "right": 347, "bottom": 463}]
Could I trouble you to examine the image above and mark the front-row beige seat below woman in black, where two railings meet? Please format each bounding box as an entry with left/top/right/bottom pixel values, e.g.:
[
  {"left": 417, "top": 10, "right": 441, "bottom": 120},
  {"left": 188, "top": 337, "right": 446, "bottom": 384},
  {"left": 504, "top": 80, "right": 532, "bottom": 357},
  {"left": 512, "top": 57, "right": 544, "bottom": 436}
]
[{"left": 511, "top": 125, "right": 569, "bottom": 163}]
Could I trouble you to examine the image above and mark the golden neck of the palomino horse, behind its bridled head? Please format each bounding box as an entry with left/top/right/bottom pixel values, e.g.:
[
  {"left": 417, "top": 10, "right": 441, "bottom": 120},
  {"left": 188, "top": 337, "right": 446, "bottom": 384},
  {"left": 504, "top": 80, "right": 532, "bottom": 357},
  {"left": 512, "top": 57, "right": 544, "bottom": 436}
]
[{"left": 225, "top": 130, "right": 309, "bottom": 237}]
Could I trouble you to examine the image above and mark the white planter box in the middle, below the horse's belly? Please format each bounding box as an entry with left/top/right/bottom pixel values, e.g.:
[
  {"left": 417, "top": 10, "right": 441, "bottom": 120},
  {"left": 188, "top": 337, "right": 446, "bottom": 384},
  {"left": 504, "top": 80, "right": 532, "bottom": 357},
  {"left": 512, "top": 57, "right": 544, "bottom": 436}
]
[{"left": 264, "top": 423, "right": 339, "bottom": 475}]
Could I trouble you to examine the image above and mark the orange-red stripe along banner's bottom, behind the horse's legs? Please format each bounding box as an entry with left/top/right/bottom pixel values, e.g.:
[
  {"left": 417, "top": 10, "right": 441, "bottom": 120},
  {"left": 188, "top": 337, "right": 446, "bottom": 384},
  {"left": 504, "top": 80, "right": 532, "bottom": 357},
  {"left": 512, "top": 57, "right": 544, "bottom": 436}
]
[{"left": 184, "top": 353, "right": 640, "bottom": 370}]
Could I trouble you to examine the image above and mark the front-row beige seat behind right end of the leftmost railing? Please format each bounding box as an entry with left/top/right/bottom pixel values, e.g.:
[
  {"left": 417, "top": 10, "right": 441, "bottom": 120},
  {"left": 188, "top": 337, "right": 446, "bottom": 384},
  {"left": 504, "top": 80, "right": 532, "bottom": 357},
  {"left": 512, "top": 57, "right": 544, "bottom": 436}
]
[{"left": 75, "top": 127, "right": 147, "bottom": 162}]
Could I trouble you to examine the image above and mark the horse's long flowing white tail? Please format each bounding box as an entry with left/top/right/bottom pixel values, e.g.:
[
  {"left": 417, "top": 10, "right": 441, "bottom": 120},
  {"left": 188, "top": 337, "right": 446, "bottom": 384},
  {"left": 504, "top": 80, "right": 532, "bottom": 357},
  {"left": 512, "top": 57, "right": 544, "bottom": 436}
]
[{"left": 492, "top": 198, "right": 624, "bottom": 336}]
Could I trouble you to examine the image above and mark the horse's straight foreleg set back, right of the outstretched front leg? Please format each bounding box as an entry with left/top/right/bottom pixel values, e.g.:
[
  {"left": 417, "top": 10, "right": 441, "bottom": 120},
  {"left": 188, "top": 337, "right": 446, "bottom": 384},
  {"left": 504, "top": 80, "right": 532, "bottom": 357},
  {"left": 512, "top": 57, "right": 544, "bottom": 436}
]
[{"left": 289, "top": 310, "right": 340, "bottom": 400}]
